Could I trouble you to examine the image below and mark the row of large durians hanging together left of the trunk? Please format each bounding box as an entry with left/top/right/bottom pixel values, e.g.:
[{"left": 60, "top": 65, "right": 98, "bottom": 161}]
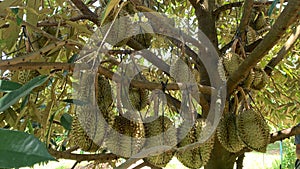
[{"left": 70, "top": 72, "right": 214, "bottom": 168}]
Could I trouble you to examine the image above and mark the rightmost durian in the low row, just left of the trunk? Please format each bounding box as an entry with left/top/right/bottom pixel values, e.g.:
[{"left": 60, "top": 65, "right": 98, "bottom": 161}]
[{"left": 176, "top": 119, "right": 214, "bottom": 169}]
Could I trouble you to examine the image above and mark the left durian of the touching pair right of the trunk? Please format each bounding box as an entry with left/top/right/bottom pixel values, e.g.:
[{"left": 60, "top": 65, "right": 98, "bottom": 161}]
[{"left": 217, "top": 113, "right": 245, "bottom": 153}]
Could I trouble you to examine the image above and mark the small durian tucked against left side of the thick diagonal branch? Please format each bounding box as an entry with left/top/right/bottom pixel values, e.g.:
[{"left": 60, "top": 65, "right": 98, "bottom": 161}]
[{"left": 223, "top": 52, "right": 243, "bottom": 76}]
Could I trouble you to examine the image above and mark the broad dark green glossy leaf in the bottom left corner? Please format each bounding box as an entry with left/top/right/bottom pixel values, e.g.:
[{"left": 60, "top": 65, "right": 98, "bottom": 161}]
[{"left": 0, "top": 129, "right": 55, "bottom": 168}]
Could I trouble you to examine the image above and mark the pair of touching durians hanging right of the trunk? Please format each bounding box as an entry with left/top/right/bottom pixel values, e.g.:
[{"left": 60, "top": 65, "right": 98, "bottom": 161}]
[{"left": 217, "top": 99, "right": 270, "bottom": 153}]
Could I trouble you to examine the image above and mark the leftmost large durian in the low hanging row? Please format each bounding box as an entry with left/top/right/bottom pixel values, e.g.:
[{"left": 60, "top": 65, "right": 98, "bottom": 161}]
[{"left": 70, "top": 105, "right": 105, "bottom": 152}]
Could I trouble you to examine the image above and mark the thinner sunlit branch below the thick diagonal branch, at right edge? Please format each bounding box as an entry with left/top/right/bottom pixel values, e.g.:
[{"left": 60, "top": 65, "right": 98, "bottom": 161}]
[{"left": 264, "top": 21, "right": 300, "bottom": 76}]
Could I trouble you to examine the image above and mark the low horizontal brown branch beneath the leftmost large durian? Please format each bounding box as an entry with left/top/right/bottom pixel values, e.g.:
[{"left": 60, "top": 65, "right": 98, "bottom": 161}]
[{"left": 48, "top": 148, "right": 118, "bottom": 163}]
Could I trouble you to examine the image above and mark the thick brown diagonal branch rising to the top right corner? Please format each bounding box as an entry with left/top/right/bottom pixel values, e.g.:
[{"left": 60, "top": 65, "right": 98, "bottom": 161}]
[{"left": 227, "top": 0, "right": 300, "bottom": 96}]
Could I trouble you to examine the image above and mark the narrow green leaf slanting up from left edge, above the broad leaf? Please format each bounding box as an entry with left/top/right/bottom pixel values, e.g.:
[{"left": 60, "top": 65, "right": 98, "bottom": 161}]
[{"left": 0, "top": 75, "right": 48, "bottom": 112}]
